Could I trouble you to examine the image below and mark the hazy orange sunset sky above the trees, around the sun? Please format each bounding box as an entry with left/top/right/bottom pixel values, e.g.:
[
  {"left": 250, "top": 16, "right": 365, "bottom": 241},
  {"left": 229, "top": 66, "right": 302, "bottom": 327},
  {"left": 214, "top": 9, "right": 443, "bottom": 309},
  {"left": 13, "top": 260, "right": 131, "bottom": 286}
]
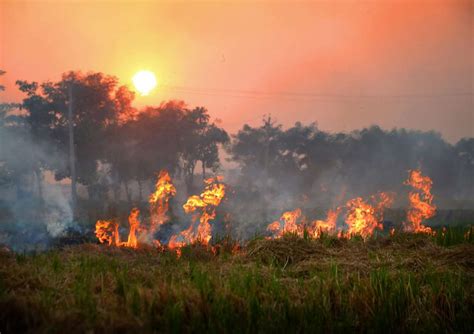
[{"left": 0, "top": 0, "right": 474, "bottom": 143}]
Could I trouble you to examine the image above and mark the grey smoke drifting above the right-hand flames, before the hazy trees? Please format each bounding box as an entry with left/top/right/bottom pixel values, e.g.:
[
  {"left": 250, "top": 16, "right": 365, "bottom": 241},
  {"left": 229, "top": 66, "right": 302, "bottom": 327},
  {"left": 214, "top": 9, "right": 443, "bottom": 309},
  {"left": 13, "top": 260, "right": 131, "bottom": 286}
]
[{"left": 218, "top": 126, "right": 474, "bottom": 239}]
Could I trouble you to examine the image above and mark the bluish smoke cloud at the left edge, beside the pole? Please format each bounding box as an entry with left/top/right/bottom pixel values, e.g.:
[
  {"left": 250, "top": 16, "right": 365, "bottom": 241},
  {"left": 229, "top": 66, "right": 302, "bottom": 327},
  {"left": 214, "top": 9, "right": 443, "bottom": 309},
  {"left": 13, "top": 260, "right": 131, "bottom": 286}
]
[{"left": 0, "top": 125, "right": 73, "bottom": 250}]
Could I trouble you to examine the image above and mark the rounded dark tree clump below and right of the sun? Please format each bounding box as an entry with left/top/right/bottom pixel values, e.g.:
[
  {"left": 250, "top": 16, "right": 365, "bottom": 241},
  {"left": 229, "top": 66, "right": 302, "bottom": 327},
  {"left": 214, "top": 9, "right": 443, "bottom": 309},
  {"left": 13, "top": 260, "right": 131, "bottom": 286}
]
[{"left": 107, "top": 101, "right": 229, "bottom": 200}]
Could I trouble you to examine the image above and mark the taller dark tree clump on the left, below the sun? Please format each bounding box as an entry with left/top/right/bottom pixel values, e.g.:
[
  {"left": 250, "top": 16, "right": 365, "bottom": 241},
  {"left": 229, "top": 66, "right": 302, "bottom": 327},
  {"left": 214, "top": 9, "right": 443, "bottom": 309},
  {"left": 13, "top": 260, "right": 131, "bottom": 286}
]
[{"left": 0, "top": 72, "right": 229, "bottom": 204}]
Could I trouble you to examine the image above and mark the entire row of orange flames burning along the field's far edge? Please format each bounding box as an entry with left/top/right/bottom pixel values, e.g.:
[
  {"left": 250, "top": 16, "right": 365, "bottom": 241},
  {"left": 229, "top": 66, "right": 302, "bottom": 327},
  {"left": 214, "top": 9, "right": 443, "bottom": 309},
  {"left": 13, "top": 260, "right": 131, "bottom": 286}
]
[{"left": 95, "top": 170, "right": 440, "bottom": 256}]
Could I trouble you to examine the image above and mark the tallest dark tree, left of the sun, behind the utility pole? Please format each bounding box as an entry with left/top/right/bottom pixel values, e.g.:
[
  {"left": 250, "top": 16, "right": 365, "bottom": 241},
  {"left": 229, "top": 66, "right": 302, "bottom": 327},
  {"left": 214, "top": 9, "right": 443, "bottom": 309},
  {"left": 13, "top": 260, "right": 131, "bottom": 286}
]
[{"left": 17, "top": 72, "right": 132, "bottom": 209}]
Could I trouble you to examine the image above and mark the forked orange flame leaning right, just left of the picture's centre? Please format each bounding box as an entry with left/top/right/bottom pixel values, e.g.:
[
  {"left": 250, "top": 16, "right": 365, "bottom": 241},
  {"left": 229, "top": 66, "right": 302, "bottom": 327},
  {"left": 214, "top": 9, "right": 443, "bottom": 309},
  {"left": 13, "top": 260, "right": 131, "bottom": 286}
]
[{"left": 168, "top": 177, "right": 225, "bottom": 249}]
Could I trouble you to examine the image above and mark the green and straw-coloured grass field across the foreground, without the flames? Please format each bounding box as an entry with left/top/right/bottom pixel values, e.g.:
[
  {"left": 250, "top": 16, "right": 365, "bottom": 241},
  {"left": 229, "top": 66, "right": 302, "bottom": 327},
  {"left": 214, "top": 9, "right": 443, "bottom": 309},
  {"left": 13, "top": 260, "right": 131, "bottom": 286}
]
[{"left": 0, "top": 227, "right": 474, "bottom": 333}]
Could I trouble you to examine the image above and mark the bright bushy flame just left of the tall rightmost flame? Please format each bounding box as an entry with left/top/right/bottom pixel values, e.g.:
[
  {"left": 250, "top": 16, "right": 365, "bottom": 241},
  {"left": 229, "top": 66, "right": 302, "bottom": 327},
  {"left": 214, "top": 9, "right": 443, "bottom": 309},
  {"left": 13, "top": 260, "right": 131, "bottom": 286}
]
[{"left": 346, "top": 193, "right": 393, "bottom": 239}]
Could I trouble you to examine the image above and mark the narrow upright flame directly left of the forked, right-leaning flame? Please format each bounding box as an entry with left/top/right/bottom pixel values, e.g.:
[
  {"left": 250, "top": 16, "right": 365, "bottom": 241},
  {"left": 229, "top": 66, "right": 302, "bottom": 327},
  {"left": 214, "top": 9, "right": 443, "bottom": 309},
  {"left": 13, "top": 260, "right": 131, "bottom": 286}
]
[{"left": 148, "top": 169, "right": 176, "bottom": 235}]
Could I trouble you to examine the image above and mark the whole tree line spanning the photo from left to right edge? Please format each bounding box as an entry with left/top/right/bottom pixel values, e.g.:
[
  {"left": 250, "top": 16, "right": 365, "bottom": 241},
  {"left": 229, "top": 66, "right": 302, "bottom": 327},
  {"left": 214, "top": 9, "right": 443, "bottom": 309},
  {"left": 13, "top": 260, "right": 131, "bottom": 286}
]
[{"left": 0, "top": 72, "right": 474, "bottom": 217}]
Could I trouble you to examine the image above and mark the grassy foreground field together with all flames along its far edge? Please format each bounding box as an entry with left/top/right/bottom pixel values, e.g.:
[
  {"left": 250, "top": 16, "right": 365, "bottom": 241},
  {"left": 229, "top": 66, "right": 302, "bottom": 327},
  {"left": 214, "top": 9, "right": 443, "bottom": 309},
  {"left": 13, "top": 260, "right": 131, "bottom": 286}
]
[{"left": 0, "top": 170, "right": 474, "bottom": 333}]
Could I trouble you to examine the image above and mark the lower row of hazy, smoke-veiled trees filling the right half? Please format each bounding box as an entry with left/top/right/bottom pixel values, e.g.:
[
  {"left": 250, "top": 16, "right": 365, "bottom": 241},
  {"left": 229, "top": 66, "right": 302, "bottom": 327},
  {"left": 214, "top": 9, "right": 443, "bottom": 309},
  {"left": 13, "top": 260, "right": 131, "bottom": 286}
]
[{"left": 229, "top": 119, "right": 474, "bottom": 209}]
